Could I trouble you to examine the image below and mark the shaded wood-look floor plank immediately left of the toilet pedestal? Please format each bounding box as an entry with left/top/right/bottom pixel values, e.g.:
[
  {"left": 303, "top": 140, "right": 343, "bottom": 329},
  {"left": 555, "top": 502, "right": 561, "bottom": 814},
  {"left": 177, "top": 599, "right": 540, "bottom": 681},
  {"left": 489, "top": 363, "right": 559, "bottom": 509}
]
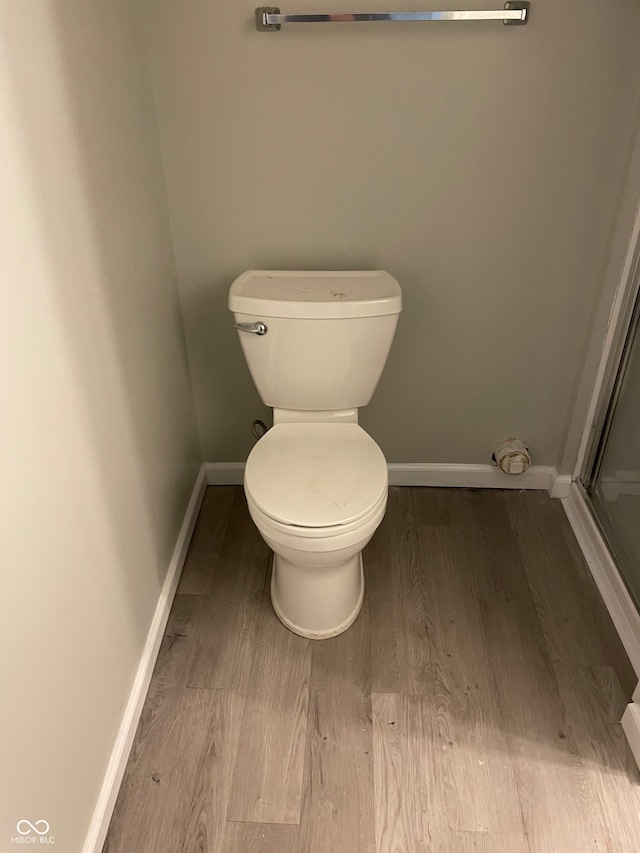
[{"left": 187, "top": 488, "right": 271, "bottom": 690}]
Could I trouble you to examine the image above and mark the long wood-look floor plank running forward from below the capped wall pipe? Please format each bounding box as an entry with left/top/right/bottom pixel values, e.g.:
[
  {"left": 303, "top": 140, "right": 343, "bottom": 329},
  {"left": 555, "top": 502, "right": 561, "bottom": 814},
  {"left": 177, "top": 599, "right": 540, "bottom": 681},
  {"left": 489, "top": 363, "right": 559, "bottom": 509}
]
[{"left": 467, "top": 493, "right": 611, "bottom": 853}]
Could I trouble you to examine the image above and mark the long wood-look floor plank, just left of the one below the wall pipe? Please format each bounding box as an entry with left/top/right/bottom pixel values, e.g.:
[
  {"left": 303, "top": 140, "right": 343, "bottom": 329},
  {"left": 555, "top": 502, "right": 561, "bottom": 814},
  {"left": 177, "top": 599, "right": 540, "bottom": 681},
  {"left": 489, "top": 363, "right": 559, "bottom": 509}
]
[{"left": 410, "top": 490, "right": 523, "bottom": 834}]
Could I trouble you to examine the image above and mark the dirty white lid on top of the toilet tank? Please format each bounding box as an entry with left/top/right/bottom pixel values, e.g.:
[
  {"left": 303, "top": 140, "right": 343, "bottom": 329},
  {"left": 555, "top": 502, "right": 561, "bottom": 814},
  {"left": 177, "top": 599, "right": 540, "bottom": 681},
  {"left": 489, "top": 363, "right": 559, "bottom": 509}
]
[{"left": 229, "top": 270, "right": 402, "bottom": 319}]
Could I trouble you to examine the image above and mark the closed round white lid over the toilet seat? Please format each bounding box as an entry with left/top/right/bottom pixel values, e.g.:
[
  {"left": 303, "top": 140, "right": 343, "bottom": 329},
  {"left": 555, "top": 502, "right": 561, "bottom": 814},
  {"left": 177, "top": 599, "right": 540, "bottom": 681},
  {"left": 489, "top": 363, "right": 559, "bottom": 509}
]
[{"left": 244, "top": 423, "right": 388, "bottom": 527}]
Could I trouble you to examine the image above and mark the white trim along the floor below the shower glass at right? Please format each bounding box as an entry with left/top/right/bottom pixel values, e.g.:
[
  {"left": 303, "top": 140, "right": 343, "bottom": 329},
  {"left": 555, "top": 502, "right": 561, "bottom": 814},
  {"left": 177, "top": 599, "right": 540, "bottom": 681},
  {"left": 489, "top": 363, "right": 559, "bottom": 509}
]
[{"left": 562, "top": 483, "right": 640, "bottom": 678}]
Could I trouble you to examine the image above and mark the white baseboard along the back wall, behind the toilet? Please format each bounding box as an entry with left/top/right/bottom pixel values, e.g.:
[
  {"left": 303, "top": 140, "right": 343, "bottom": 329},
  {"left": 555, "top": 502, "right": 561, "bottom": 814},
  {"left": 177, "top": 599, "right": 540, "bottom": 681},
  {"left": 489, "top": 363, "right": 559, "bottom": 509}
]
[{"left": 206, "top": 462, "right": 571, "bottom": 497}]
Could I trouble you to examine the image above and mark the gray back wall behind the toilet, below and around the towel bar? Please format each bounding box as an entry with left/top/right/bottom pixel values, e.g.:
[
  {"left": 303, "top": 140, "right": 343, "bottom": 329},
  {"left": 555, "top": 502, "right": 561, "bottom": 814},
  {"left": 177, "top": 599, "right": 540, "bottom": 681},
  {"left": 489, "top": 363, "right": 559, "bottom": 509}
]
[{"left": 147, "top": 0, "right": 640, "bottom": 465}]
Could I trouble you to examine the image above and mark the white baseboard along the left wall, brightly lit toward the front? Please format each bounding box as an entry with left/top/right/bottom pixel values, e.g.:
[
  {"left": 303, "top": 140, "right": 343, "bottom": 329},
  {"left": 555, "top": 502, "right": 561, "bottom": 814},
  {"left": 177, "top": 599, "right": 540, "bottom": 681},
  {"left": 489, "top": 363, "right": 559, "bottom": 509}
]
[{"left": 82, "top": 465, "right": 207, "bottom": 853}]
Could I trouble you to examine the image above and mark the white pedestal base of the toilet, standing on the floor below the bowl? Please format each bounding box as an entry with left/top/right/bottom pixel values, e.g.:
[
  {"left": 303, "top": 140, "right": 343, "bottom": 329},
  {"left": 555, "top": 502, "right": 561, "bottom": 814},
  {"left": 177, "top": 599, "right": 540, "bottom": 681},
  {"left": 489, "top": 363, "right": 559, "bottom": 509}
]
[{"left": 271, "top": 552, "right": 364, "bottom": 640}]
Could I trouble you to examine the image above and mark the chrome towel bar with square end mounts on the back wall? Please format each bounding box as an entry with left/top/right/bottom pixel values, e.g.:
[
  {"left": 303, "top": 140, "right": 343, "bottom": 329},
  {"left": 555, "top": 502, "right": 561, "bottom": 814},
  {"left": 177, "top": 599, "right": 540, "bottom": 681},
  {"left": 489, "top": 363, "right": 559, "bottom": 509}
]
[{"left": 256, "top": 0, "right": 529, "bottom": 32}]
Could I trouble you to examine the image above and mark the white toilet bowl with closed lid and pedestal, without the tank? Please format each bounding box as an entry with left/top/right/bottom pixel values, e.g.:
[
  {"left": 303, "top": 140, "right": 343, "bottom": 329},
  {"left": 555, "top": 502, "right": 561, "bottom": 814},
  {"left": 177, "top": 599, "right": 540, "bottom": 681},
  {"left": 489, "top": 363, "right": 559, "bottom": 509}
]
[{"left": 244, "top": 423, "right": 388, "bottom": 639}]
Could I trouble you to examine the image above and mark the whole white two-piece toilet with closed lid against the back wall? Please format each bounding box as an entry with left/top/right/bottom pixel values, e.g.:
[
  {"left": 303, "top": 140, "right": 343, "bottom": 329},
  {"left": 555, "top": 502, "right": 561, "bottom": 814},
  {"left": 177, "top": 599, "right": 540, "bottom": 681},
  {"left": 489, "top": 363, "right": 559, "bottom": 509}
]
[{"left": 229, "top": 270, "right": 402, "bottom": 639}]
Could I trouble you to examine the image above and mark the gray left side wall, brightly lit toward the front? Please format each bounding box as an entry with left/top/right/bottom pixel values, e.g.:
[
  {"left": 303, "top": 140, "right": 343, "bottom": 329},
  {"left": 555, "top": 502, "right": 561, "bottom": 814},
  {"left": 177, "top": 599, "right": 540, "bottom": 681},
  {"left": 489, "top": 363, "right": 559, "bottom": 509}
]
[{"left": 0, "top": 0, "right": 200, "bottom": 853}]
